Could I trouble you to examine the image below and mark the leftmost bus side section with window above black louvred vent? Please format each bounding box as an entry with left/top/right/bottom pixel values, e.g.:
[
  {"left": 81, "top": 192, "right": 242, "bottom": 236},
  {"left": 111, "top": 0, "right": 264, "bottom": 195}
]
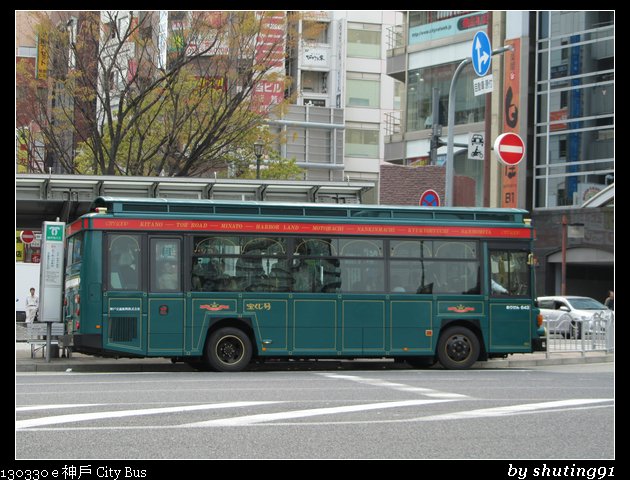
[{"left": 105, "top": 232, "right": 147, "bottom": 355}]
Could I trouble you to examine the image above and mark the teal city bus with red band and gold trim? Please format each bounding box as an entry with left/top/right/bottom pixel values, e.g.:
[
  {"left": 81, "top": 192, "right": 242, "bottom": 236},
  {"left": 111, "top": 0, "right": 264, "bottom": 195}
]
[{"left": 61, "top": 197, "right": 545, "bottom": 371}]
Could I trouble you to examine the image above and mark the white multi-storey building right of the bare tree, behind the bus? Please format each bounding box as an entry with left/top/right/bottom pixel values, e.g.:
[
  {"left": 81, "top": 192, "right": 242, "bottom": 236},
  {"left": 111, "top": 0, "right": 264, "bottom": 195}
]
[{"left": 287, "top": 10, "right": 402, "bottom": 191}]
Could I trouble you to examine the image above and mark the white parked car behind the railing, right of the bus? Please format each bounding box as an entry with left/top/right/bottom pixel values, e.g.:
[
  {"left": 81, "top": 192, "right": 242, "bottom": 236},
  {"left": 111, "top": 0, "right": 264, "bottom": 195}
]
[{"left": 537, "top": 296, "right": 612, "bottom": 339}]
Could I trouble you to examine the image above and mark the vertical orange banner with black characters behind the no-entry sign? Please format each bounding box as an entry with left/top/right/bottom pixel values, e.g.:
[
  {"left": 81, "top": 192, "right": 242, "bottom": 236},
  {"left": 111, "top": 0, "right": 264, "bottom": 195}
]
[{"left": 500, "top": 38, "right": 521, "bottom": 208}]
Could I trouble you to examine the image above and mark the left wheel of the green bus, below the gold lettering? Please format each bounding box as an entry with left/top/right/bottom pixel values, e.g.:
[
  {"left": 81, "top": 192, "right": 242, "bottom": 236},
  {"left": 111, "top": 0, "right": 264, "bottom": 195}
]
[{"left": 206, "top": 327, "right": 252, "bottom": 372}]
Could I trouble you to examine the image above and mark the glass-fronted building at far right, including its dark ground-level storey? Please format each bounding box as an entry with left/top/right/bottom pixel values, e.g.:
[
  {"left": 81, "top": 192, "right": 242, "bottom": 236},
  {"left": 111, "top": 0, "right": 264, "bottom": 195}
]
[{"left": 531, "top": 11, "right": 615, "bottom": 301}]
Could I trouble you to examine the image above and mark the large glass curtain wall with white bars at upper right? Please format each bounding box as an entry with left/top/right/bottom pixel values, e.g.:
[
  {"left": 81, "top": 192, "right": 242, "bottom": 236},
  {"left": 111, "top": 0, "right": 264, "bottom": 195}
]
[{"left": 534, "top": 11, "right": 615, "bottom": 208}]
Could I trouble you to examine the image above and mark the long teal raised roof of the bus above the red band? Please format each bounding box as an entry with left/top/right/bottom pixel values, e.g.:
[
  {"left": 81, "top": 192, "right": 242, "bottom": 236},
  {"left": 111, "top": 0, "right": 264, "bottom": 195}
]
[{"left": 90, "top": 197, "right": 528, "bottom": 224}]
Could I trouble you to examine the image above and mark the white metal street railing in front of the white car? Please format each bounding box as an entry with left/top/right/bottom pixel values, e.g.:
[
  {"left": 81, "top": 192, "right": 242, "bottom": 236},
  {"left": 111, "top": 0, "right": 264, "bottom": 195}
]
[{"left": 546, "top": 312, "right": 615, "bottom": 357}]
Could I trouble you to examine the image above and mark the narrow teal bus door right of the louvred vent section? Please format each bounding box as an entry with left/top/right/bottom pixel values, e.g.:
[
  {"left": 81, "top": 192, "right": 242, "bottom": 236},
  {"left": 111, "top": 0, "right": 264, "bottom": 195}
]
[{"left": 147, "top": 235, "right": 184, "bottom": 356}]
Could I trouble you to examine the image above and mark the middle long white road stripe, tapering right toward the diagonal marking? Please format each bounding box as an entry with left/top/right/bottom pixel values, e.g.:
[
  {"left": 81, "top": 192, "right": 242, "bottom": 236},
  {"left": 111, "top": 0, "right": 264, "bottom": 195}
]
[{"left": 185, "top": 399, "right": 452, "bottom": 427}]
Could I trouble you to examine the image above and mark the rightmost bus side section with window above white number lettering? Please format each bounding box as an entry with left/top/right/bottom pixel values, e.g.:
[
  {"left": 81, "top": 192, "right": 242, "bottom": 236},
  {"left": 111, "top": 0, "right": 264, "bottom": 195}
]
[{"left": 486, "top": 245, "right": 533, "bottom": 352}]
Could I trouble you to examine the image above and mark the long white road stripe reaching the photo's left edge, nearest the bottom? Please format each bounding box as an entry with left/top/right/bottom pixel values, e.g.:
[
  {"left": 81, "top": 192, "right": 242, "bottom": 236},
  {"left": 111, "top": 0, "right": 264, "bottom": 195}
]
[{"left": 15, "top": 401, "right": 282, "bottom": 430}]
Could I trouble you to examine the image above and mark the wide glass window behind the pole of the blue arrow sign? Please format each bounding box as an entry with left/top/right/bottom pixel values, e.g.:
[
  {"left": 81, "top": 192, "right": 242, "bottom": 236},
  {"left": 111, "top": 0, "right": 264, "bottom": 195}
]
[{"left": 407, "top": 62, "right": 485, "bottom": 131}]
